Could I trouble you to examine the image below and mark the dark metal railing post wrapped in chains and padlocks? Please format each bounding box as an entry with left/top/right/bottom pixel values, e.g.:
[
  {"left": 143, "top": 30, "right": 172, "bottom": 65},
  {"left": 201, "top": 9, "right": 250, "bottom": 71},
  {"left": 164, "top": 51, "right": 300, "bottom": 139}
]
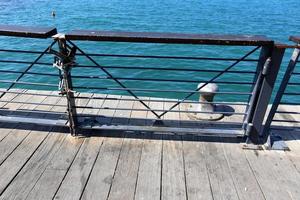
[{"left": 53, "top": 34, "right": 78, "bottom": 136}]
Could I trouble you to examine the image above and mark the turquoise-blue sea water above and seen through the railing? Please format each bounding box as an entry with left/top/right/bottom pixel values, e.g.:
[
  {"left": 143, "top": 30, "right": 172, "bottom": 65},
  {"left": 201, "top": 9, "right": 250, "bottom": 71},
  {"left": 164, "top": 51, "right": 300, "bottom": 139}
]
[{"left": 0, "top": 0, "right": 300, "bottom": 101}]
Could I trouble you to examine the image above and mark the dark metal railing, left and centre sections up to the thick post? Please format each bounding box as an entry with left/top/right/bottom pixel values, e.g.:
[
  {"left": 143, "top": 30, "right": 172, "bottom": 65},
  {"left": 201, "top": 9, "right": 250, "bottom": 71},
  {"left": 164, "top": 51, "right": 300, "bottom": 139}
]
[{"left": 0, "top": 26, "right": 284, "bottom": 143}]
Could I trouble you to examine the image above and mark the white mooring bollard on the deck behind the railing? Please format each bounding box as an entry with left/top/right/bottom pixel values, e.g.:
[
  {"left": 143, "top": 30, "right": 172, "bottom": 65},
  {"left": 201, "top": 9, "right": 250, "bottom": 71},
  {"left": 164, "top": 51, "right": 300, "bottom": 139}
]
[{"left": 188, "top": 83, "right": 224, "bottom": 121}]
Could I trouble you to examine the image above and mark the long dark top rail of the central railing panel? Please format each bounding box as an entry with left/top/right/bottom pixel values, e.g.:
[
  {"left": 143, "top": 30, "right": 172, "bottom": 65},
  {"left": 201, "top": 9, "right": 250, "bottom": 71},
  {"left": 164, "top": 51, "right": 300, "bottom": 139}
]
[{"left": 65, "top": 30, "right": 274, "bottom": 46}]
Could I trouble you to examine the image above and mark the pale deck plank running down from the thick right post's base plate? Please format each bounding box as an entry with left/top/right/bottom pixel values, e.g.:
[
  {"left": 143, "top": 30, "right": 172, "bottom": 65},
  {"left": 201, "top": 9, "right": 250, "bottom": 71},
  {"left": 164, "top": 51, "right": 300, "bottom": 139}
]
[{"left": 244, "top": 150, "right": 292, "bottom": 200}]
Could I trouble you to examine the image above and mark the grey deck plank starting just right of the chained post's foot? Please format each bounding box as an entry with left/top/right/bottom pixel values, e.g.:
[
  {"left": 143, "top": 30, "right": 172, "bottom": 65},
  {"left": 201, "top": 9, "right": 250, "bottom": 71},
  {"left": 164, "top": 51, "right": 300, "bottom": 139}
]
[{"left": 54, "top": 137, "right": 103, "bottom": 200}]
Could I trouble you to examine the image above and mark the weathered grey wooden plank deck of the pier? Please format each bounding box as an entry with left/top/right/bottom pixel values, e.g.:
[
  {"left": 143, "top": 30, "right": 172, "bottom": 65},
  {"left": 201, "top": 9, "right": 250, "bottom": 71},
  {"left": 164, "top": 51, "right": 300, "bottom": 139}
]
[{"left": 0, "top": 91, "right": 300, "bottom": 200}]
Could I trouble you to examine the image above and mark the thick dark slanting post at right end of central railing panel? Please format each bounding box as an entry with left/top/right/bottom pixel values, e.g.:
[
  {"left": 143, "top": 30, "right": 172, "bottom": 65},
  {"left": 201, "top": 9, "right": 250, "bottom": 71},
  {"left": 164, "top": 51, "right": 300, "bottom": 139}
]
[{"left": 248, "top": 45, "right": 285, "bottom": 144}]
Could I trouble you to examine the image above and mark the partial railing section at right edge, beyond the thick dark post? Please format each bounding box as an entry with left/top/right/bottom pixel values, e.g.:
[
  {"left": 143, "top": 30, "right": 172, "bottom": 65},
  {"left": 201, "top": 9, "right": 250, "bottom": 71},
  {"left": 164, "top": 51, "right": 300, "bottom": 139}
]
[{"left": 263, "top": 36, "right": 300, "bottom": 139}]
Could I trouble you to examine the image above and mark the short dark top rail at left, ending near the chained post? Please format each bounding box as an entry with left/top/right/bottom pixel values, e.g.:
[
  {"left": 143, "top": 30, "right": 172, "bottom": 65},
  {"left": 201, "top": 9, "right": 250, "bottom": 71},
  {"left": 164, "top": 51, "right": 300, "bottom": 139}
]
[{"left": 0, "top": 25, "right": 57, "bottom": 38}]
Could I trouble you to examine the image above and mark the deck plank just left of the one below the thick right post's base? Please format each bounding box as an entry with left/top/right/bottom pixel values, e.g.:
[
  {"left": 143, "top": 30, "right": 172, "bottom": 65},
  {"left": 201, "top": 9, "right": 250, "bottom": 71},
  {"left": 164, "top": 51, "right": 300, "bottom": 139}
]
[{"left": 222, "top": 143, "right": 265, "bottom": 200}]
